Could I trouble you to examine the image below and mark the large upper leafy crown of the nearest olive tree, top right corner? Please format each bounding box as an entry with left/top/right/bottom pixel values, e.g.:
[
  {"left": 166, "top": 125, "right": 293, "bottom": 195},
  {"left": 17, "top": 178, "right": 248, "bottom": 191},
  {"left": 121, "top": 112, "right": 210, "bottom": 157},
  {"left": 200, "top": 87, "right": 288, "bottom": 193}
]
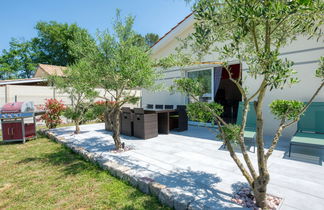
[{"left": 188, "top": 0, "right": 324, "bottom": 89}]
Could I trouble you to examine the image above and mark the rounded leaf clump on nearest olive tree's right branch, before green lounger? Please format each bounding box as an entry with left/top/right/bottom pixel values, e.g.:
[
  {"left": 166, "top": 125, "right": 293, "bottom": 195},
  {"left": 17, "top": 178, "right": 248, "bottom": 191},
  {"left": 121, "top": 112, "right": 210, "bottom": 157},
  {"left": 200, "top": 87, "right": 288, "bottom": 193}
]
[{"left": 270, "top": 100, "right": 305, "bottom": 120}]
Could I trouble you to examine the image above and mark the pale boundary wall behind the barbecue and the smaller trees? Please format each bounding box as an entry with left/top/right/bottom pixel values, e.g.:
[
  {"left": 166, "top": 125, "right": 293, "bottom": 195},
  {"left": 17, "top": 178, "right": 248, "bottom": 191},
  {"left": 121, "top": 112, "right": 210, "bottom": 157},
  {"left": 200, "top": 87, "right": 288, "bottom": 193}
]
[{"left": 0, "top": 85, "right": 141, "bottom": 108}]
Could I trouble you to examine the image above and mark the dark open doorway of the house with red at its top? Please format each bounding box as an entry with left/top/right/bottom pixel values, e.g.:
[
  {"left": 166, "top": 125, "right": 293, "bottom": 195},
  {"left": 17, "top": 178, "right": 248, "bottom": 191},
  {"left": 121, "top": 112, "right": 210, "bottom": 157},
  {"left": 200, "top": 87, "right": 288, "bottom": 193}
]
[{"left": 214, "top": 64, "right": 242, "bottom": 123}]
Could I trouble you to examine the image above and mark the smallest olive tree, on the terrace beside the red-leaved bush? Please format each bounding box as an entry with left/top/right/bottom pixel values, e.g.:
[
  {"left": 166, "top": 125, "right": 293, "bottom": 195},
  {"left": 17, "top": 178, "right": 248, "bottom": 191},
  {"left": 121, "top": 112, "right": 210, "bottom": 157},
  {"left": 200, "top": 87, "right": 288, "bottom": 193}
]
[{"left": 49, "top": 61, "right": 98, "bottom": 134}]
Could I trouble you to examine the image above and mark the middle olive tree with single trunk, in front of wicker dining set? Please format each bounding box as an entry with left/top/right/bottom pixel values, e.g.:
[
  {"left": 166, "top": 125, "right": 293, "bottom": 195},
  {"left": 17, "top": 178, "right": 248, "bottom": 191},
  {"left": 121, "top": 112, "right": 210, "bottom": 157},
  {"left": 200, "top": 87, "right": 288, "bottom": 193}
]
[{"left": 71, "top": 12, "right": 158, "bottom": 149}]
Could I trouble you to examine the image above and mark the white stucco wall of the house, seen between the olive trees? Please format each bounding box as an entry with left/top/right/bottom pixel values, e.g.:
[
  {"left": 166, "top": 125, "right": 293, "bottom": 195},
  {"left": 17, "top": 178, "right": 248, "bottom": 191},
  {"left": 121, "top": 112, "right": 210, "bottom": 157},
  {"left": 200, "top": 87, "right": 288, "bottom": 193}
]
[{"left": 142, "top": 16, "right": 324, "bottom": 138}]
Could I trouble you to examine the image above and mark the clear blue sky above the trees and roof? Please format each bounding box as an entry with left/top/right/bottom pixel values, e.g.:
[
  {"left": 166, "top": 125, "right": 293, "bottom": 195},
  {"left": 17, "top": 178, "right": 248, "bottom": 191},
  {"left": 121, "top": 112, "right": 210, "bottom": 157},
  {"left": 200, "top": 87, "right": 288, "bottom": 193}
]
[{"left": 0, "top": 0, "right": 190, "bottom": 51}]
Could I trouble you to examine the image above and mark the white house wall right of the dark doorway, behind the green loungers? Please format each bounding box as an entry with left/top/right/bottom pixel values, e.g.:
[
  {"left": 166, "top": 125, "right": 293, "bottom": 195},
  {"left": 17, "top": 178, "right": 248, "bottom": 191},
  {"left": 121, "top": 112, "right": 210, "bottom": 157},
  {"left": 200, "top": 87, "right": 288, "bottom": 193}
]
[{"left": 243, "top": 40, "right": 324, "bottom": 137}]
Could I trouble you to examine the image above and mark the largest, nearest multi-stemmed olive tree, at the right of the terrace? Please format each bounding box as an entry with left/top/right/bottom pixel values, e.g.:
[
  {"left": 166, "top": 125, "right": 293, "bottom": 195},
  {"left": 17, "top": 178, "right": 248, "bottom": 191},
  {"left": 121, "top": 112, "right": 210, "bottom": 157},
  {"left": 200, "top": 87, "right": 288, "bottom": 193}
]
[{"left": 170, "top": 0, "right": 324, "bottom": 208}]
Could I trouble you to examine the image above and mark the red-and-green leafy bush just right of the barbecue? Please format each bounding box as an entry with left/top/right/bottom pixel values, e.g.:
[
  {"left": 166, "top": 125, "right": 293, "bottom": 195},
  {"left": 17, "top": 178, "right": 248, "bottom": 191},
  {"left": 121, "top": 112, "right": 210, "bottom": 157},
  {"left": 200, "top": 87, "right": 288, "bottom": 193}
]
[{"left": 40, "top": 99, "right": 66, "bottom": 129}]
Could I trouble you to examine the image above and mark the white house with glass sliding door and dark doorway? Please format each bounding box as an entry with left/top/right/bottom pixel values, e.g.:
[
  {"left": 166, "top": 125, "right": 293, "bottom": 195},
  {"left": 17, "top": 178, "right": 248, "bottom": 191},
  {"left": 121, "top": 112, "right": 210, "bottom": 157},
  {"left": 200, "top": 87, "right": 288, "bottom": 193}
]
[{"left": 142, "top": 14, "right": 324, "bottom": 137}]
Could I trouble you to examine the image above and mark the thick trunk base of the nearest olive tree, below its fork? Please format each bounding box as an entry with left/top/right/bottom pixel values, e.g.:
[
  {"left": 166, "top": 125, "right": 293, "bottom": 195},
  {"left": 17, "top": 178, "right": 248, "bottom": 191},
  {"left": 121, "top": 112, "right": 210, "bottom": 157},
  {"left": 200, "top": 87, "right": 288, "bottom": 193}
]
[{"left": 253, "top": 173, "right": 269, "bottom": 209}]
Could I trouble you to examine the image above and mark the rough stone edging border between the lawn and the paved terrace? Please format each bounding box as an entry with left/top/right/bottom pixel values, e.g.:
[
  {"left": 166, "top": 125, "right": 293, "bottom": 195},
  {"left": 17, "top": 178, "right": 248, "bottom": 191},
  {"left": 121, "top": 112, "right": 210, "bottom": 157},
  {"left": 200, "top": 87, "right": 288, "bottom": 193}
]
[{"left": 38, "top": 129, "right": 196, "bottom": 210}]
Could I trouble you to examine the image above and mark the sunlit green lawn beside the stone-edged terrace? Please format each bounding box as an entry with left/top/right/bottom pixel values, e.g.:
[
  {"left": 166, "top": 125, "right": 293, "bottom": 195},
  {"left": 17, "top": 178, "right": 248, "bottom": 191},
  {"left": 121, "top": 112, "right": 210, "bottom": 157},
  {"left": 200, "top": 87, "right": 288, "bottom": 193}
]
[{"left": 0, "top": 137, "right": 167, "bottom": 210}]
